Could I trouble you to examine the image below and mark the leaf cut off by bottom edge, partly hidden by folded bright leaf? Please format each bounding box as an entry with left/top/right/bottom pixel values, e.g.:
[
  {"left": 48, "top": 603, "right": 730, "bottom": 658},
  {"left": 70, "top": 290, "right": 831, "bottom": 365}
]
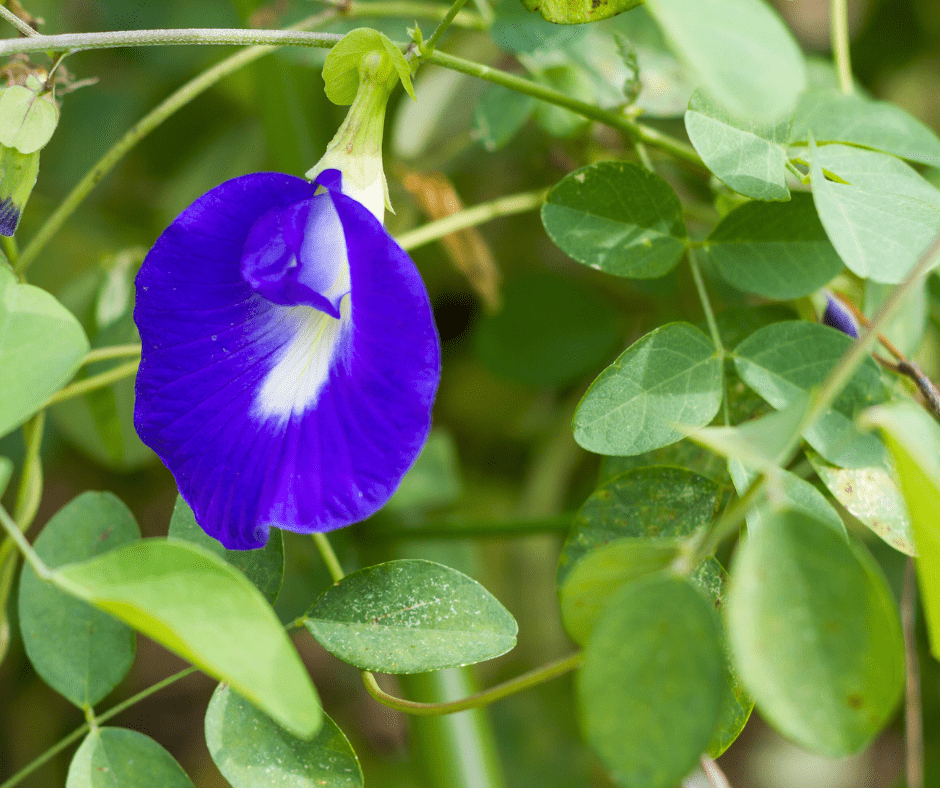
[{"left": 206, "top": 684, "right": 363, "bottom": 788}]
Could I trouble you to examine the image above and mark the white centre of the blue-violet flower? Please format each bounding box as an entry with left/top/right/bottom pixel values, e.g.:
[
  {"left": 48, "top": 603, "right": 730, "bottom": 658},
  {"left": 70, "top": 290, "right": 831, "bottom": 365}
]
[{"left": 252, "top": 194, "right": 352, "bottom": 423}]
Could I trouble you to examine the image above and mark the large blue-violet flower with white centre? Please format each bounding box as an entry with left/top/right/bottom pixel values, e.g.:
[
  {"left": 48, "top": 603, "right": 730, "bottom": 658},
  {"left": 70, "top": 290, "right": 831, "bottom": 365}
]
[{"left": 134, "top": 169, "right": 440, "bottom": 549}]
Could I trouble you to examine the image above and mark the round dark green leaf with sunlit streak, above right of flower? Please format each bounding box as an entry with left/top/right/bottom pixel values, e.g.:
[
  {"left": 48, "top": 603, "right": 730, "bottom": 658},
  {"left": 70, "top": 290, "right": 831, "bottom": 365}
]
[{"left": 542, "top": 161, "right": 686, "bottom": 279}]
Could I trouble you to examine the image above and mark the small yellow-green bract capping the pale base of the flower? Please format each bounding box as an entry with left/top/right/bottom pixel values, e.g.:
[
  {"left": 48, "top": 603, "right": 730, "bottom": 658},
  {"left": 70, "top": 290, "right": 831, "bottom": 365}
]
[{"left": 323, "top": 27, "right": 416, "bottom": 106}]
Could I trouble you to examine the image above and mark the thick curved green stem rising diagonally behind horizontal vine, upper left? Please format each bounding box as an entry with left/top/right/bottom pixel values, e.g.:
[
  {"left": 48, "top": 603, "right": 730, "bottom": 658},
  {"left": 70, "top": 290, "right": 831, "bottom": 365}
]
[{"left": 11, "top": 9, "right": 337, "bottom": 273}]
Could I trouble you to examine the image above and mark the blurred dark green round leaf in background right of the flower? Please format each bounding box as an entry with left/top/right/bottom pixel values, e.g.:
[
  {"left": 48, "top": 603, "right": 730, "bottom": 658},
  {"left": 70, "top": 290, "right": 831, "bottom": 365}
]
[{"left": 474, "top": 274, "right": 618, "bottom": 386}]
